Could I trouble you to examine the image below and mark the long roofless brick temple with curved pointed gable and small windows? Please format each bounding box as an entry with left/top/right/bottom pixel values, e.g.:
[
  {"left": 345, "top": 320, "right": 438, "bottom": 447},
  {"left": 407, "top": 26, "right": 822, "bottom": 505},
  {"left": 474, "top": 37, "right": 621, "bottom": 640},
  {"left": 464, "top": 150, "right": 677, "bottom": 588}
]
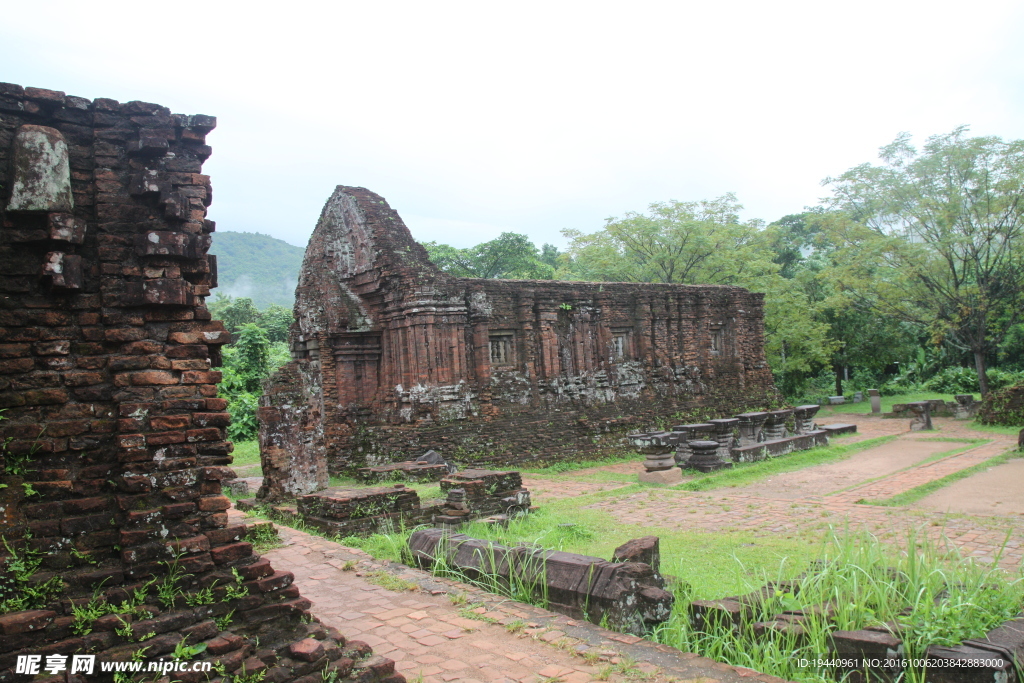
[{"left": 259, "top": 186, "right": 776, "bottom": 500}]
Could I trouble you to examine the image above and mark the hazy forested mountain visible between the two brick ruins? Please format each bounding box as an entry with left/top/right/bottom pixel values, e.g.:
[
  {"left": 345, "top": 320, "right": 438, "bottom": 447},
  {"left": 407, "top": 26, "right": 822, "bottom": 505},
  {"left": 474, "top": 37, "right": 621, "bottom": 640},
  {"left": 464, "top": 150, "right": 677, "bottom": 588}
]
[{"left": 210, "top": 232, "right": 306, "bottom": 309}]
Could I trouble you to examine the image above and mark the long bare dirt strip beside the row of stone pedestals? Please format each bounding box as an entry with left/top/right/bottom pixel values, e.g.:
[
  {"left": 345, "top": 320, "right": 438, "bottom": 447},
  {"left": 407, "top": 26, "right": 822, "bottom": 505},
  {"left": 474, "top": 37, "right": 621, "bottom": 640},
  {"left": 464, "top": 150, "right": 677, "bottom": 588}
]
[{"left": 744, "top": 436, "right": 966, "bottom": 499}]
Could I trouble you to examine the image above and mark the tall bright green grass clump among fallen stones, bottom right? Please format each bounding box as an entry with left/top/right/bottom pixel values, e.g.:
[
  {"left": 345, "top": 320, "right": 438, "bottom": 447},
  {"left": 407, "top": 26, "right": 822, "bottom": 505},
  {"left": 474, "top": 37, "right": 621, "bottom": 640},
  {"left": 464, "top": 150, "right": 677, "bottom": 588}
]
[{"left": 654, "top": 531, "right": 1024, "bottom": 683}]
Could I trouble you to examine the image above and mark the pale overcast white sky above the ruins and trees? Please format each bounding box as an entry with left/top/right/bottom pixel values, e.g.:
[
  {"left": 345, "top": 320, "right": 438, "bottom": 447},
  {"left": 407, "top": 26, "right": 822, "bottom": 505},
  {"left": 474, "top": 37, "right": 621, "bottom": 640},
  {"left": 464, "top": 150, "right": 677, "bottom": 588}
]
[{"left": 8, "top": 0, "right": 1024, "bottom": 247}]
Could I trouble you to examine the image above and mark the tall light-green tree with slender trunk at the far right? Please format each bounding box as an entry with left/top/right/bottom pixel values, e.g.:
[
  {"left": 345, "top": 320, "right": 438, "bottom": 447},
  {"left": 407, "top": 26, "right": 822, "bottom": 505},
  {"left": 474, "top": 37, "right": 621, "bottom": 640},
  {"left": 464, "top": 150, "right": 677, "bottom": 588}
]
[{"left": 825, "top": 127, "right": 1024, "bottom": 394}]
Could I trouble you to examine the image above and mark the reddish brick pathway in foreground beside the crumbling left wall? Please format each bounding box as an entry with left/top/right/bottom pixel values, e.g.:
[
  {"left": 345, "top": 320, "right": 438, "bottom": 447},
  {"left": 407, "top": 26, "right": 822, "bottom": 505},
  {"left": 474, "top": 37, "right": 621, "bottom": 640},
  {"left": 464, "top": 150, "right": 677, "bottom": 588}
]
[{"left": 231, "top": 510, "right": 780, "bottom": 683}]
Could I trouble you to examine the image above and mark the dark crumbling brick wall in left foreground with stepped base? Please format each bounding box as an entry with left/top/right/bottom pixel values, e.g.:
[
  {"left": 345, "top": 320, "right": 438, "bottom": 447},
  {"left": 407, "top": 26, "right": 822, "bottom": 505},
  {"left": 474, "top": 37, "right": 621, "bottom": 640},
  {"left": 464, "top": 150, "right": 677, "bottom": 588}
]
[{"left": 0, "top": 84, "right": 404, "bottom": 683}]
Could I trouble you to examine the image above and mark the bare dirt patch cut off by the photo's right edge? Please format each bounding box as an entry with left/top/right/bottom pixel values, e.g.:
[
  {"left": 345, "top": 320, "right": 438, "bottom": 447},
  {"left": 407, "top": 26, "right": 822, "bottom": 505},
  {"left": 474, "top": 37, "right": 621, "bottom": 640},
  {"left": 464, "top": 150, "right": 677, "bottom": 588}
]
[{"left": 911, "top": 460, "right": 1024, "bottom": 516}]
